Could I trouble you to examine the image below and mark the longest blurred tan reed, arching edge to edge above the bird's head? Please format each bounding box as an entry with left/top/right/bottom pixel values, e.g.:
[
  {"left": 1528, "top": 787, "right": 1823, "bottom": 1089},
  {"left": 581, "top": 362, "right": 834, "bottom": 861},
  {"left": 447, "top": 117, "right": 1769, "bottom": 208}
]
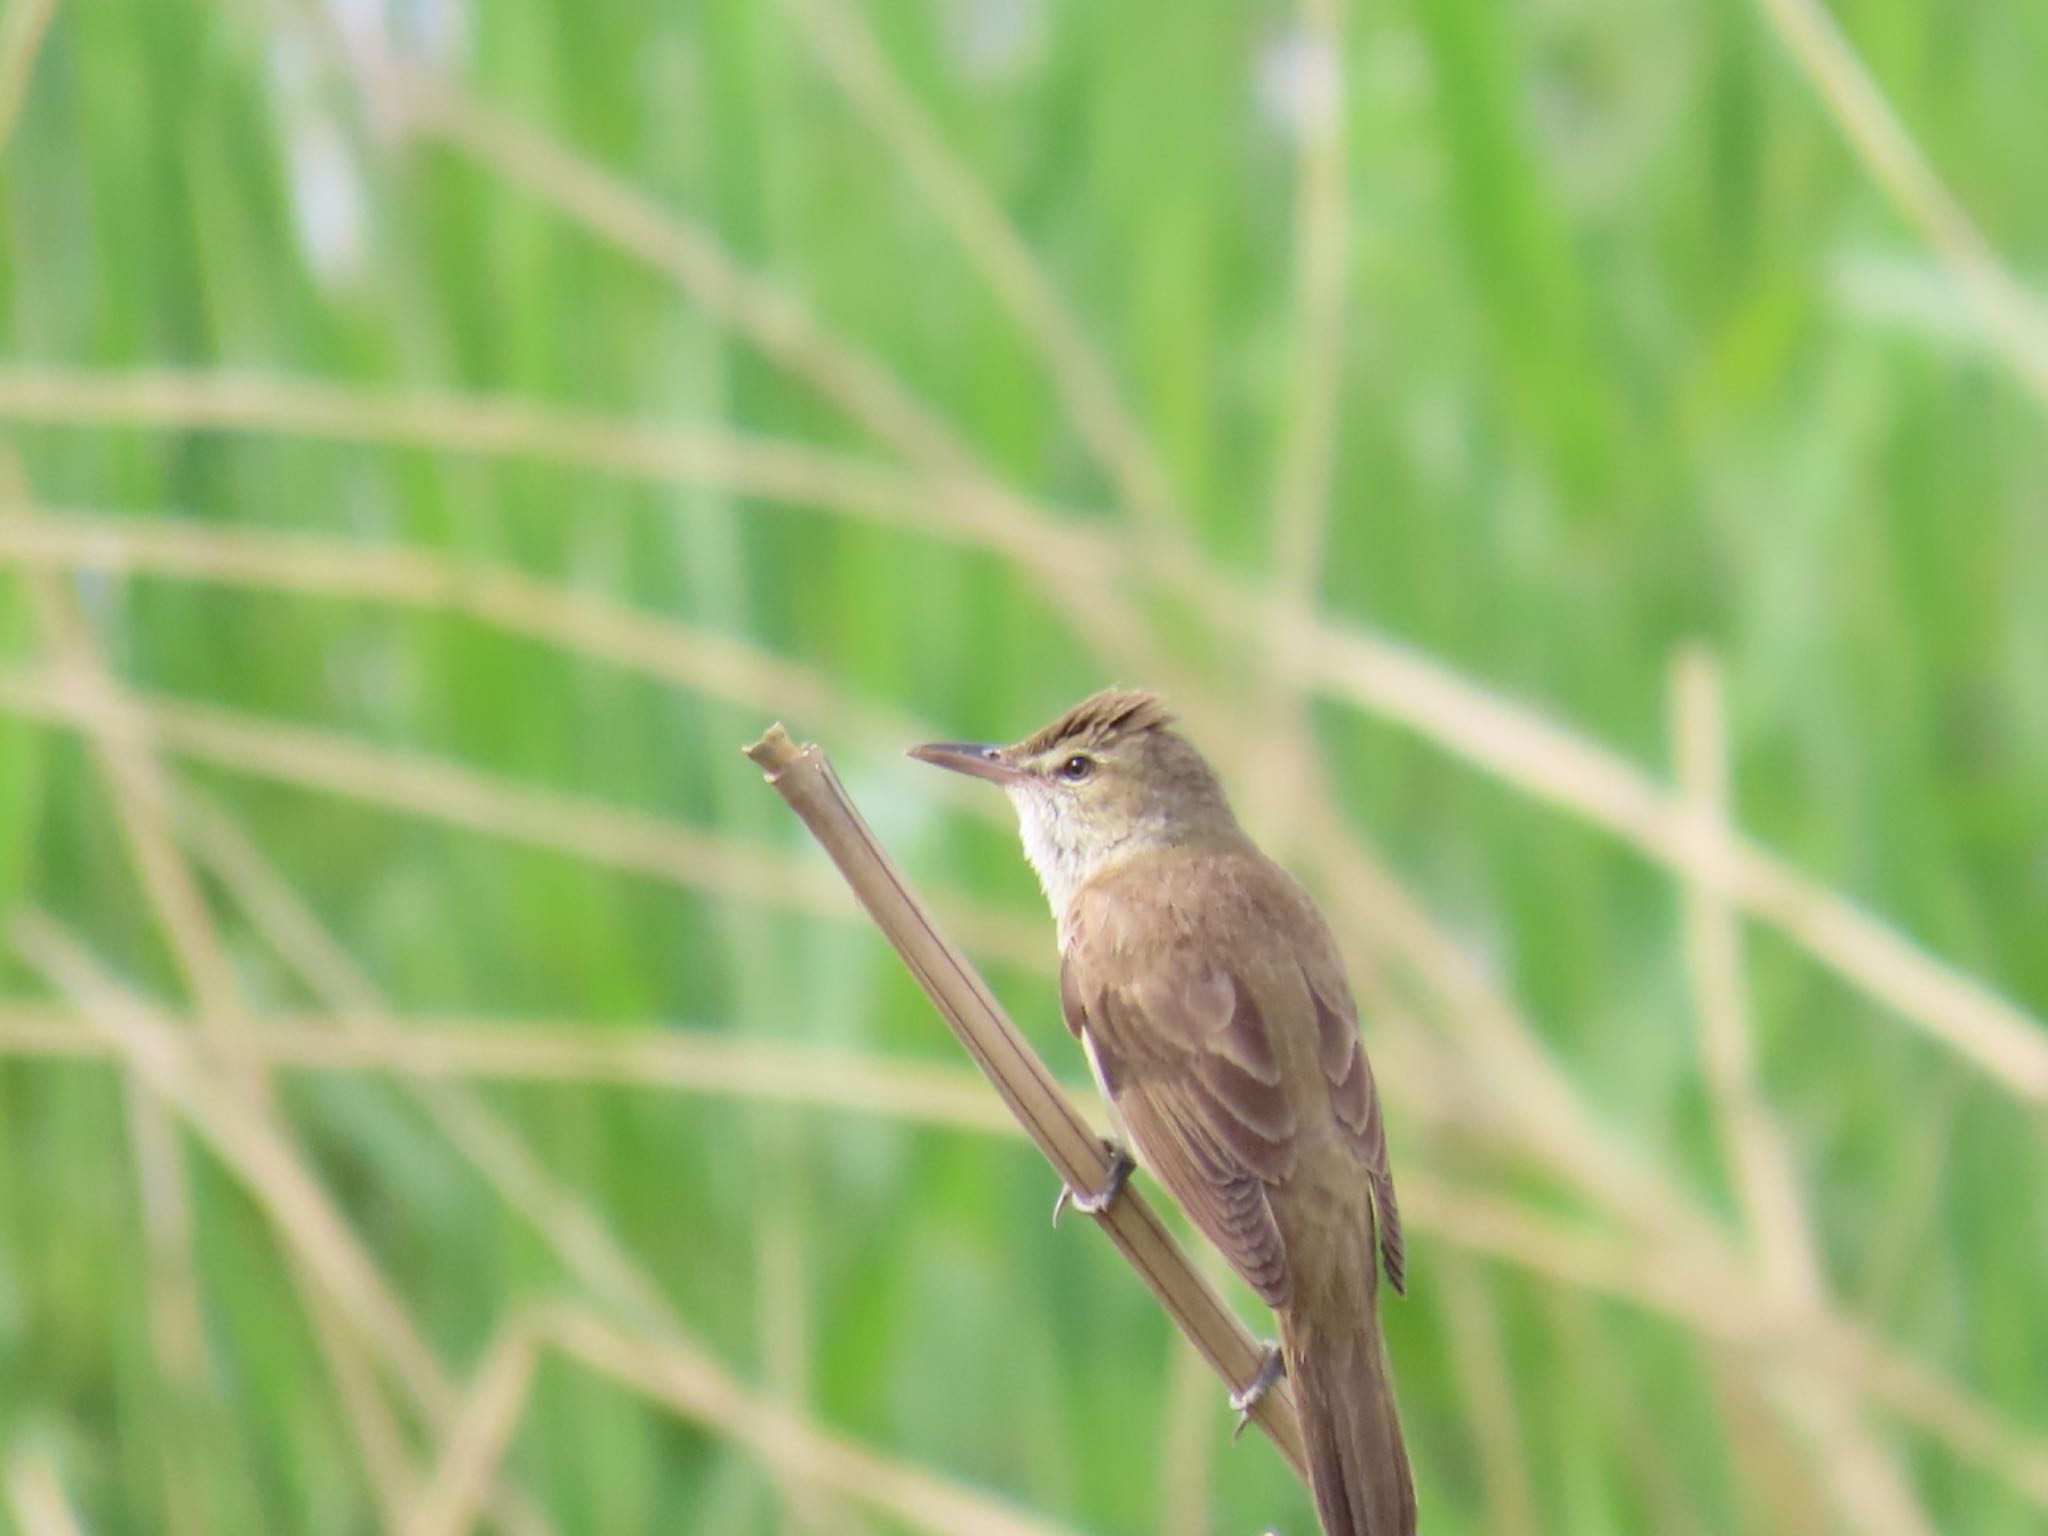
[{"left": 0, "top": 369, "right": 2048, "bottom": 1122}]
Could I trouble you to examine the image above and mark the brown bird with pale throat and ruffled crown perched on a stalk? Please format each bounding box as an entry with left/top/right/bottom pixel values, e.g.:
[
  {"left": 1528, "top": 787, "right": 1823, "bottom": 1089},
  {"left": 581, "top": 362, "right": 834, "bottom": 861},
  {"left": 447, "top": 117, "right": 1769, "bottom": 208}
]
[{"left": 911, "top": 690, "right": 1415, "bottom": 1536}]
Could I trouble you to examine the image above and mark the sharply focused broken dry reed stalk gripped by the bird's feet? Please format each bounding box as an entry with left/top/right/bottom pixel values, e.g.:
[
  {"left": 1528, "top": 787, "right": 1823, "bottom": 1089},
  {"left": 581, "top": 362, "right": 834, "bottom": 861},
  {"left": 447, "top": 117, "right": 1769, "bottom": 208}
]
[{"left": 748, "top": 725, "right": 1305, "bottom": 1473}]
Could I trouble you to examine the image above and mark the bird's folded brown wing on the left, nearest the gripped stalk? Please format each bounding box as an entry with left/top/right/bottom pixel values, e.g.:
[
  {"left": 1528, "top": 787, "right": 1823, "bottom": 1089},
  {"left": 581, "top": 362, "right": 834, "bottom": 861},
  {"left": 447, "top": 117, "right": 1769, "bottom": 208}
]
[{"left": 1059, "top": 958, "right": 1294, "bottom": 1307}]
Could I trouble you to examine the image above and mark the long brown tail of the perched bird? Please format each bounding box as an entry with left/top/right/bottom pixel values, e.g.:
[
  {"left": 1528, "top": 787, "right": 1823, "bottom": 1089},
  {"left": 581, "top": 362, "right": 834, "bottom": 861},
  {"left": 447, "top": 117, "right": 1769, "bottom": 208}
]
[{"left": 1280, "top": 1296, "right": 1415, "bottom": 1536}]
